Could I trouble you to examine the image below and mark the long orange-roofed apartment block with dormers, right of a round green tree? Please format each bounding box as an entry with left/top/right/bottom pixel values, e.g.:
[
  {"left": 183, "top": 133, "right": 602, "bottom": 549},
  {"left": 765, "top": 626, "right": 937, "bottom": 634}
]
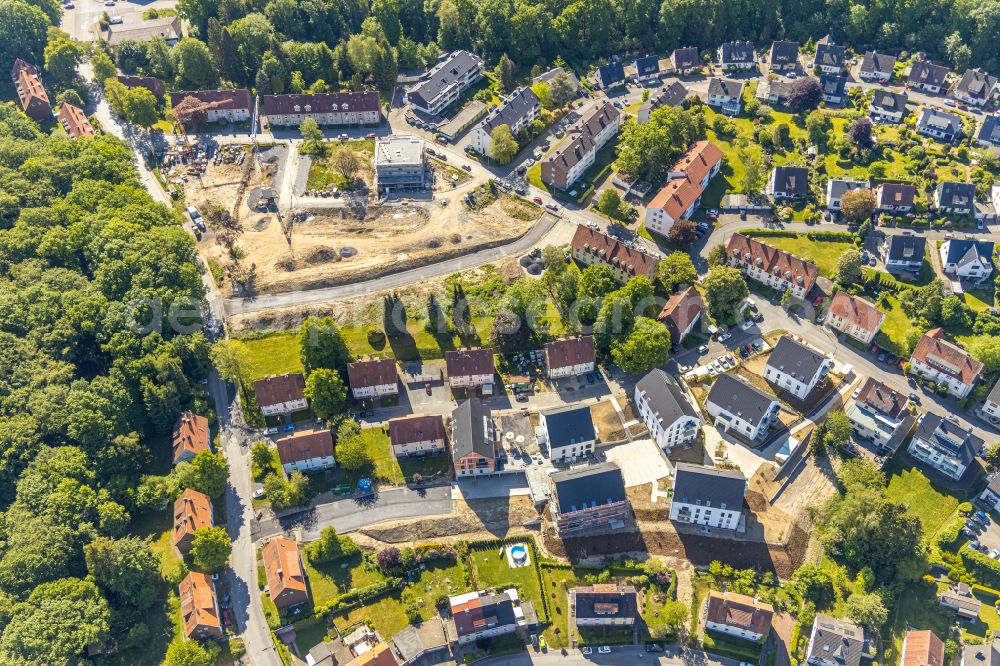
[{"left": 726, "top": 234, "right": 819, "bottom": 298}]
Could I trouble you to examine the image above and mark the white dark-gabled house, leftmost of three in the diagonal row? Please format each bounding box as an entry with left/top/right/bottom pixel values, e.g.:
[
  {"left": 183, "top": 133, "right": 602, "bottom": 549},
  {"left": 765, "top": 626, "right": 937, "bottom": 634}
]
[{"left": 634, "top": 368, "right": 702, "bottom": 450}]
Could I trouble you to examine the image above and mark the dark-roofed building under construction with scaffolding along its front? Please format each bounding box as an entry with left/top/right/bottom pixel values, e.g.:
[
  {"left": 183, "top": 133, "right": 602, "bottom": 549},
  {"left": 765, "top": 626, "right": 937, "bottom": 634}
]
[{"left": 549, "top": 462, "right": 629, "bottom": 535}]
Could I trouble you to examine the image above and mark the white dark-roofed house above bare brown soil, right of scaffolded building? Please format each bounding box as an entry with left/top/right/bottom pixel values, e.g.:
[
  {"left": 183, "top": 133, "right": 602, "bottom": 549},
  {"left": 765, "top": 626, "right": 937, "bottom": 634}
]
[{"left": 670, "top": 464, "right": 747, "bottom": 530}]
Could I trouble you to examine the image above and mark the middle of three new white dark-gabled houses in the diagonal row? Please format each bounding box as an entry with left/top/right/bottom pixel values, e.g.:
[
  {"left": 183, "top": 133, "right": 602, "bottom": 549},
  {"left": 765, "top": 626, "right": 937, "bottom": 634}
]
[{"left": 705, "top": 372, "right": 781, "bottom": 441}]
